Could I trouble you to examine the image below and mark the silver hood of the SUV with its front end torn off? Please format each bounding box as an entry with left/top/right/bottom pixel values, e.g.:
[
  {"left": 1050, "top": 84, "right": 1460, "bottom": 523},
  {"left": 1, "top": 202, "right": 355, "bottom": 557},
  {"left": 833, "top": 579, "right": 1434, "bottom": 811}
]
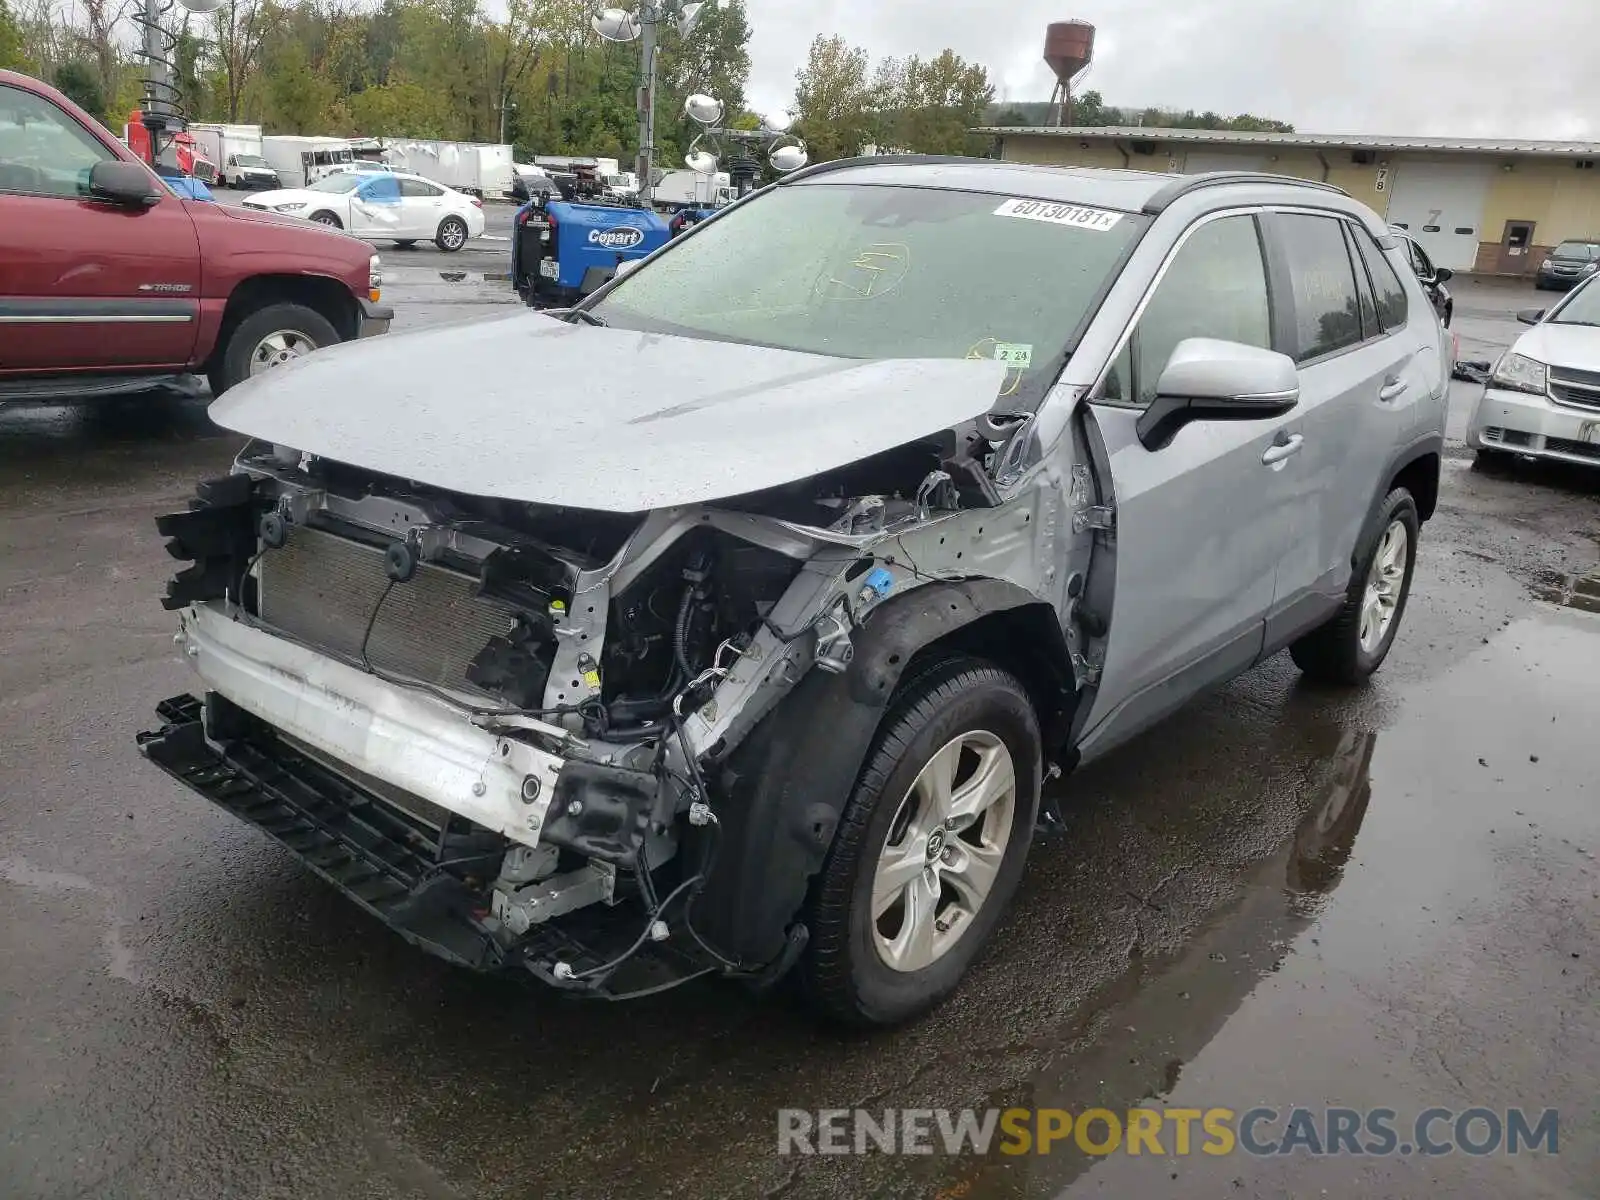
[{"left": 211, "top": 312, "right": 1005, "bottom": 512}]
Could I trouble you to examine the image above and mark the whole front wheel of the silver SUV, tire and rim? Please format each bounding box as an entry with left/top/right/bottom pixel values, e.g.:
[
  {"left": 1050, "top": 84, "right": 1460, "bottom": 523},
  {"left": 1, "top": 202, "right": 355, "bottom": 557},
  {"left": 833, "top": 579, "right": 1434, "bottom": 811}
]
[{"left": 802, "top": 658, "right": 1042, "bottom": 1026}]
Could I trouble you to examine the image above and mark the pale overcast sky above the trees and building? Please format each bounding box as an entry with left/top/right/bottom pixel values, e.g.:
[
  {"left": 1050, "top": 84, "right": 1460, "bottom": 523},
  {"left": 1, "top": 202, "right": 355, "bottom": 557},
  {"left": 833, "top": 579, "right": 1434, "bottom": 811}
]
[{"left": 746, "top": 0, "right": 1600, "bottom": 139}]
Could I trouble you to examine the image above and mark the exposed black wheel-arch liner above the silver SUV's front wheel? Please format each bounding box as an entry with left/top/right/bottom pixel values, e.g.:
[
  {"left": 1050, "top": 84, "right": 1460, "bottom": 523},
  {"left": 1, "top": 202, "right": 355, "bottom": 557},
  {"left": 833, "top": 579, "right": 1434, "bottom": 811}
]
[{"left": 694, "top": 579, "right": 1059, "bottom": 963}]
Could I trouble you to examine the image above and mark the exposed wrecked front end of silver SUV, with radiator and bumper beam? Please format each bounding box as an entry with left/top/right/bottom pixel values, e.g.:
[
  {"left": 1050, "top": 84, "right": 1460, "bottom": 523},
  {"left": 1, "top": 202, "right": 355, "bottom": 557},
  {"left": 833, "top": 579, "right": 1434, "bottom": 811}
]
[{"left": 139, "top": 428, "right": 1081, "bottom": 997}]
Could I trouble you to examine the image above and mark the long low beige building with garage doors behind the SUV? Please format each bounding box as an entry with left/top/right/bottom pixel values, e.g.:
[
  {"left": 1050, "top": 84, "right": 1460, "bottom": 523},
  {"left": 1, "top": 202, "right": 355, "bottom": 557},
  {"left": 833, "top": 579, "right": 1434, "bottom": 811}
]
[{"left": 978, "top": 128, "right": 1600, "bottom": 275}]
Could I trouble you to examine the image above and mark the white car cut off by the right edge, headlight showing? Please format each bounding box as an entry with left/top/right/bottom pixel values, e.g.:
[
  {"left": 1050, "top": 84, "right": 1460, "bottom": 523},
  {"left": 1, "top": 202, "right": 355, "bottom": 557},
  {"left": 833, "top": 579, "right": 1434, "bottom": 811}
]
[{"left": 1467, "top": 277, "right": 1600, "bottom": 466}]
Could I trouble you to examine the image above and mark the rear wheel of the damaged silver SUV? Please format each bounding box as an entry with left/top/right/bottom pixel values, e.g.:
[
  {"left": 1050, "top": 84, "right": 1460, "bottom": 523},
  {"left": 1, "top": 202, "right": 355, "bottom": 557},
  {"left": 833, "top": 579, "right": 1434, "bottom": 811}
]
[{"left": 1290, "top": 488, "right": 1421, "bottom": 685}]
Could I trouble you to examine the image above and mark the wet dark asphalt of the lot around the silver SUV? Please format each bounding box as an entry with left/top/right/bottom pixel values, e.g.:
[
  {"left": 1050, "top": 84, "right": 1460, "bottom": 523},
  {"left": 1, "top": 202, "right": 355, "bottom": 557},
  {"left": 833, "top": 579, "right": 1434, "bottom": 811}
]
[{"left": 0, "top": 275, "right": 1600, "bottom": 1200}]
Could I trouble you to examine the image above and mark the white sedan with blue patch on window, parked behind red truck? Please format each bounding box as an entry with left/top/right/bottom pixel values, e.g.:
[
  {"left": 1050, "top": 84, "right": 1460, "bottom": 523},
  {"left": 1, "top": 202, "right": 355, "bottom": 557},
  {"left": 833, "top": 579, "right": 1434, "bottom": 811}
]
[{"left": 245, "top": 171, "right": 483, "bottom": 251}]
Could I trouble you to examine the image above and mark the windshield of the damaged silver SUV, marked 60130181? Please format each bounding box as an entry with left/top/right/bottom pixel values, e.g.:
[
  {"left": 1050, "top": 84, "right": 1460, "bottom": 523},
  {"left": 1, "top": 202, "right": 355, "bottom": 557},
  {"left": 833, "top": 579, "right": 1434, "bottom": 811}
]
[{"left": 594, "top": 184, "right": 1146, "bottom": 406}]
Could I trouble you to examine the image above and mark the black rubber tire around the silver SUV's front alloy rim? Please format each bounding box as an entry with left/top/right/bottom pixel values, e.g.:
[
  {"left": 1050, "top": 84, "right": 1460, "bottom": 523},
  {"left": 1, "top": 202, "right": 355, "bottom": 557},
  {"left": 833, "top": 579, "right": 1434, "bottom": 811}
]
[{"left": 800, "top": 658, "right": 1042, "bottom": 1026}]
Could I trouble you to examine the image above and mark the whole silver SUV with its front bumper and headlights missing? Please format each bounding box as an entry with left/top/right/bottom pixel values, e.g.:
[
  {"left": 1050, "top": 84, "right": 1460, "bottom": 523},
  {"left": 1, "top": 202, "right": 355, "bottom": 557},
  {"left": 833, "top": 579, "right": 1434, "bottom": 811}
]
[{"left": 141, "top": 158, "right": 1450, "bottom": 1024}]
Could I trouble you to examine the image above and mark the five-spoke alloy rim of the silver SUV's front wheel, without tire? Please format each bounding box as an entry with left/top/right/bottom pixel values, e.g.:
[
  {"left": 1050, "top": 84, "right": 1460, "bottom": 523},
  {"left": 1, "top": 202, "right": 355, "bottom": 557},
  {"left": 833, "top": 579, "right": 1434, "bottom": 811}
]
[{"left": 872, "top": 730, "right": 1018, "bottom": 971}]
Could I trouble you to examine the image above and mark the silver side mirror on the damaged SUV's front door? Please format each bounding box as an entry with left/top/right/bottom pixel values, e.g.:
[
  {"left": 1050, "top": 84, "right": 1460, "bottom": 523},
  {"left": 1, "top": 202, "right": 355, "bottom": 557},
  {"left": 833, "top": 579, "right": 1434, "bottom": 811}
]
[{"left": 1136, "top": 338, "right": 1299, "bottom": 450}]
